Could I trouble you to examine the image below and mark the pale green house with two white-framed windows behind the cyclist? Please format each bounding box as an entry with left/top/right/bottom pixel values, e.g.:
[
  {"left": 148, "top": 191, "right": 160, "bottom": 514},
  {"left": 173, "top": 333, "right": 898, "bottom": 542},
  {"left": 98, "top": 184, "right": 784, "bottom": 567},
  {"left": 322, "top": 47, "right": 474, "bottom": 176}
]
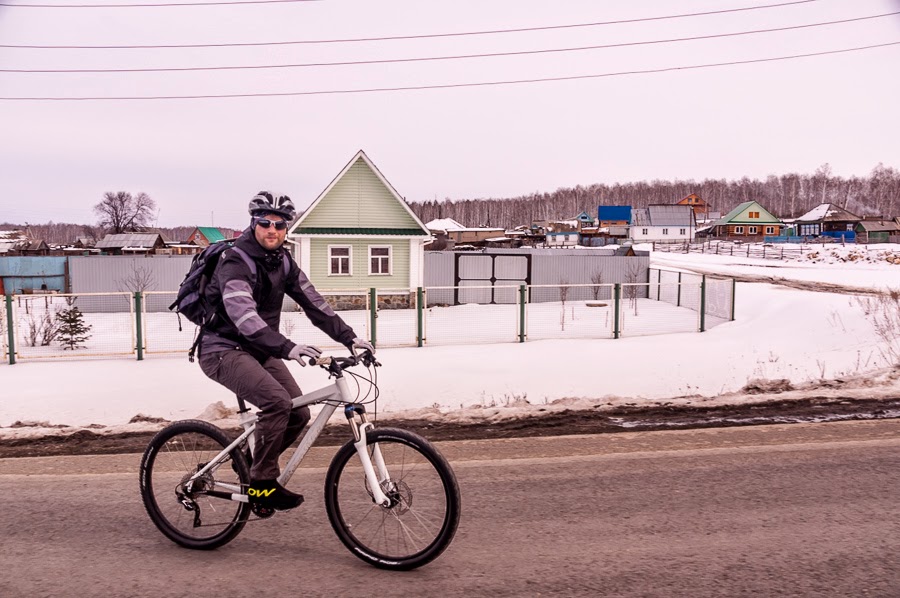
[{"left": 289, "top": 150, "right": 431, "bottom": 300}]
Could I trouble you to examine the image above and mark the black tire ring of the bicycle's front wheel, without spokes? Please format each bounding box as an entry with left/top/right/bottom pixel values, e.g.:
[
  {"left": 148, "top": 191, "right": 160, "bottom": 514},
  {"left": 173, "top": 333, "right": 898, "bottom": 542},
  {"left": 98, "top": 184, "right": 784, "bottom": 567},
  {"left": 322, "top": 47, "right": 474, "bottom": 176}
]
[{"left": 325, "top": 428, "right": 461, "bottom": 571}]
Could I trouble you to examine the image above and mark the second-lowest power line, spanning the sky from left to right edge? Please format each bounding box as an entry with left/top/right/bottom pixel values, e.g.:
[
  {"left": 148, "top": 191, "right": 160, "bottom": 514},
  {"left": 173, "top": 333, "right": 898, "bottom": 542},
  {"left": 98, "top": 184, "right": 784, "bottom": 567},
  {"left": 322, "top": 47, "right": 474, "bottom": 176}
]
[{"left": 0, "top": 11, "right": 900, "bottom": 74}]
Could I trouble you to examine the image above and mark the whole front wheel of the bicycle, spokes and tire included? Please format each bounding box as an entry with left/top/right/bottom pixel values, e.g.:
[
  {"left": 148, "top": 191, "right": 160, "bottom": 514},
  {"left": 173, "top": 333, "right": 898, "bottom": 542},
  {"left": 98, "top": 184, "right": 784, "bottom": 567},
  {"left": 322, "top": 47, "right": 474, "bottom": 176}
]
[{"left": 325, "top": 428, "right": 460, "bottom": 570}]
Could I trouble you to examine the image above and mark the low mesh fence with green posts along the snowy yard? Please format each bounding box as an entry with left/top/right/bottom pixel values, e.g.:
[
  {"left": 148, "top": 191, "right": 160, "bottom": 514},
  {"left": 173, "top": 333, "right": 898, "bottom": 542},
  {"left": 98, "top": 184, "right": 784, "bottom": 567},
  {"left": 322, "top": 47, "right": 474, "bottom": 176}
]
[{"left": 0, "top": 269, "right": 734, "bottom": 363}]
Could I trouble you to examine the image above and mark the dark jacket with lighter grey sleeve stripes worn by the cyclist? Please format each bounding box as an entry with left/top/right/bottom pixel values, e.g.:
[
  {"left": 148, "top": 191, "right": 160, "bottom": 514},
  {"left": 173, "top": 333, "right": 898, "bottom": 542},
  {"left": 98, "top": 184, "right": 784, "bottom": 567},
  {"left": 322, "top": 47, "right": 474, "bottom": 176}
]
[{"left": 200, "top": 229, "right": 356, "bottom": 361}]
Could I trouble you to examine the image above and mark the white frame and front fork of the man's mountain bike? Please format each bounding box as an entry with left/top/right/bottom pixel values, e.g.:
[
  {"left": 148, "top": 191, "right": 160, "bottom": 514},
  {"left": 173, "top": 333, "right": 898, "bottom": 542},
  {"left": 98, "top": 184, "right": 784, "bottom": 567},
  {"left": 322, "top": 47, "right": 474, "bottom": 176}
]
[{"left": 191, "top": 378, "right": 390, "bottom": 506}]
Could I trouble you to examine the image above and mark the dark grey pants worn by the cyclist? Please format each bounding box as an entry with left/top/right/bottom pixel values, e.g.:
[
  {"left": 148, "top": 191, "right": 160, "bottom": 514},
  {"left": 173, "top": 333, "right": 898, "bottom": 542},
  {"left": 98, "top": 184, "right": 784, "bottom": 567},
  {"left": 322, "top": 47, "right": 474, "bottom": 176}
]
[{"left": 200, "top": 349, "right": 309, "bottom": 481}]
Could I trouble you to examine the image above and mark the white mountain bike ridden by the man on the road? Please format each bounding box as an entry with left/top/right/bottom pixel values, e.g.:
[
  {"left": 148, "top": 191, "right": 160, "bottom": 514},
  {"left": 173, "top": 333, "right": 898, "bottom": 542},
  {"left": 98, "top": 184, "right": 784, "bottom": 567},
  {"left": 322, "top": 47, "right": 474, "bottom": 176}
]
[{"left": 140, "top": 353, "right": 460, "bottom": 570}]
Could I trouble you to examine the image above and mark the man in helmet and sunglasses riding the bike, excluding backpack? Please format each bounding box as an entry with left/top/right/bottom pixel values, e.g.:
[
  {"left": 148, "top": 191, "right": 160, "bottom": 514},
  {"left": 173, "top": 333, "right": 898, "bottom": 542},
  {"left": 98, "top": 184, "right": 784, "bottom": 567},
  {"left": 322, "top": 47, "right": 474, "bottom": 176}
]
[{"left": 199, "top": 191, "right": 375, "bottom": 510}]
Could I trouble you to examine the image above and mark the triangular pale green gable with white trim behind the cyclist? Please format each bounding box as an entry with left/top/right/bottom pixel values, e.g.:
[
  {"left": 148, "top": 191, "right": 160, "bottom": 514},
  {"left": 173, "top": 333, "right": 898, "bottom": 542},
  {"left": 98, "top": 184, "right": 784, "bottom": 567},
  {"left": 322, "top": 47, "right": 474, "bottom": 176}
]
[{"left": 291, "top": 150, "right": 431, "bottom": 237}]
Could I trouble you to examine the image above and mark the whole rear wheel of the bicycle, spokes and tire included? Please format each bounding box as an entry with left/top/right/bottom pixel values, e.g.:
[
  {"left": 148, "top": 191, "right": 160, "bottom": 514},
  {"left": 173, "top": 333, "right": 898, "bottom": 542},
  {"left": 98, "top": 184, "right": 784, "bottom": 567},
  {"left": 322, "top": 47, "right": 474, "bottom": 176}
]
[{"left": 141, "top": 420, "right": 250, "bottom": 549}]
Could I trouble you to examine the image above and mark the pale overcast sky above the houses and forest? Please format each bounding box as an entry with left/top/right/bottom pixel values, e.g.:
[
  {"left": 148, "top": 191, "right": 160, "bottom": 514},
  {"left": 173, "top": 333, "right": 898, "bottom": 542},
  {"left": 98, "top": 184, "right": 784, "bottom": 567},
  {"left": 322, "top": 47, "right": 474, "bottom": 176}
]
[{"left": 0, "top": 0, "right": 900, "bottom": 228}]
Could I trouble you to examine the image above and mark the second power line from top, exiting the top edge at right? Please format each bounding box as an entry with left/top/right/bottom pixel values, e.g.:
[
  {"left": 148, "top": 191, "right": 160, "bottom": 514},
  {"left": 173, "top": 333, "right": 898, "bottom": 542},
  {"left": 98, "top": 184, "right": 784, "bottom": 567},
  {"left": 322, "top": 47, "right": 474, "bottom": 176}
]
[{"left": 0, "top": 0, "right": 819, "bottom": 43}]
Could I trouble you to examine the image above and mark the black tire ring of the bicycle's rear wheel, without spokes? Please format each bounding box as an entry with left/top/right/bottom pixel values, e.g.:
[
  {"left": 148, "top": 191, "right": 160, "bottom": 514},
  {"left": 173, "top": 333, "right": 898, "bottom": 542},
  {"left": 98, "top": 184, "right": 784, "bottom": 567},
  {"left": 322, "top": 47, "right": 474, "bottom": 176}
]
[{"left": 140, "top": 420, "right": 250, "bottom": 550}]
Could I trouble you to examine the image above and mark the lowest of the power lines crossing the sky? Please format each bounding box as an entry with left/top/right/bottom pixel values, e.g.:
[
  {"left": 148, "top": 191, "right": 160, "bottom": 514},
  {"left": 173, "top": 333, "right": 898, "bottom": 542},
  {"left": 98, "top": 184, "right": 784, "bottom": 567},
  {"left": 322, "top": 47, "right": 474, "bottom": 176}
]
[{"left": 0, "top": 41, "right": 900, "bottom": 102}]
